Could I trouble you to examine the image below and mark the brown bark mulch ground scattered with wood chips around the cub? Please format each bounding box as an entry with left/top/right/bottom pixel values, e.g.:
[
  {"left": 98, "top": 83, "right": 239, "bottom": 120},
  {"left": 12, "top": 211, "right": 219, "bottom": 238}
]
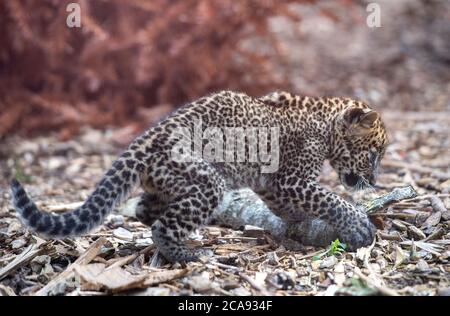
[{"left": 0, "top": 111, "right": 450, "bottom": 295}]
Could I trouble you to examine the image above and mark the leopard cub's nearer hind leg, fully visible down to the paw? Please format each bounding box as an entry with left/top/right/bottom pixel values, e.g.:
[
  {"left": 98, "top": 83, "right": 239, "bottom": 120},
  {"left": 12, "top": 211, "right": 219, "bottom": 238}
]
[{"left": 149, "top": 162, "right": 225, "bottom": 262}]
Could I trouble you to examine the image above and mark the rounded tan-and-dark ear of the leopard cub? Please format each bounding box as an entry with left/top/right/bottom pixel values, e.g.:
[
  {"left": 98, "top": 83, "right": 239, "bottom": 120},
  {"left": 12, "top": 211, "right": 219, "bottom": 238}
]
[{"left": 342, "top": 107, "right": 379, "bottom": 134}]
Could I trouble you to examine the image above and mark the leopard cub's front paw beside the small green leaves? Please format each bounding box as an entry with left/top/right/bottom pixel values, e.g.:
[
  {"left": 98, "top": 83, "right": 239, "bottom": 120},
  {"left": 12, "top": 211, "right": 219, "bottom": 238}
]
[{"left": 339, "top": 213, "right": 376, "bottom": 251}]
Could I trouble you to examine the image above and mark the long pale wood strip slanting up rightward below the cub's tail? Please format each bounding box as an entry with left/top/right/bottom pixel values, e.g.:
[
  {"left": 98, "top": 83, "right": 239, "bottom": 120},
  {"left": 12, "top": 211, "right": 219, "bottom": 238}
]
[{"left": 34, "top": 238, "right": 107, "bottom": 296}]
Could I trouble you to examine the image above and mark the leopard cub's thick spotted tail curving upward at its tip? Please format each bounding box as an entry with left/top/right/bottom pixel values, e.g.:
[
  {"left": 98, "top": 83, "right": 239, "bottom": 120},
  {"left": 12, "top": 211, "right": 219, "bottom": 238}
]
[{"left": 11, "top": 152, "right": 139, "bottom": 238}]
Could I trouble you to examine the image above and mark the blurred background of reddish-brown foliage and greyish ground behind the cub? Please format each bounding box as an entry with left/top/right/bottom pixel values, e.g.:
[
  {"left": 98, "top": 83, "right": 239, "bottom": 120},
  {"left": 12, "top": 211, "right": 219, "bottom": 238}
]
[{"left": 0, "top": 0, "right": 450, "bottom": 142}]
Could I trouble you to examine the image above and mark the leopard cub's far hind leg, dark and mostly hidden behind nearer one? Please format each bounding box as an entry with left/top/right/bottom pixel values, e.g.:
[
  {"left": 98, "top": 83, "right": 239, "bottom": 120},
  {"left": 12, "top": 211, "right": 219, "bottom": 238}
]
[{"left": 136, "top": 192, "right": 167, "bottom": 226}]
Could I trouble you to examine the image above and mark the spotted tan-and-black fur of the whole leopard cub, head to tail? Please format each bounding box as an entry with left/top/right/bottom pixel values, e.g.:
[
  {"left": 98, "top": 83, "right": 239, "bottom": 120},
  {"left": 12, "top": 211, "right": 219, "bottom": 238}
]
[{"left": 11, "top": 91, "right": 387, "bottom": 261}]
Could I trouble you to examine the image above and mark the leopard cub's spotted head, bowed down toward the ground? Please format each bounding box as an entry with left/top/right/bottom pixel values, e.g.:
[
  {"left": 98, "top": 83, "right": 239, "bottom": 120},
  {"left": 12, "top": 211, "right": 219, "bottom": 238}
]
[{"left": 330, "top": 102, "right": 388, "bottom": 190}]
